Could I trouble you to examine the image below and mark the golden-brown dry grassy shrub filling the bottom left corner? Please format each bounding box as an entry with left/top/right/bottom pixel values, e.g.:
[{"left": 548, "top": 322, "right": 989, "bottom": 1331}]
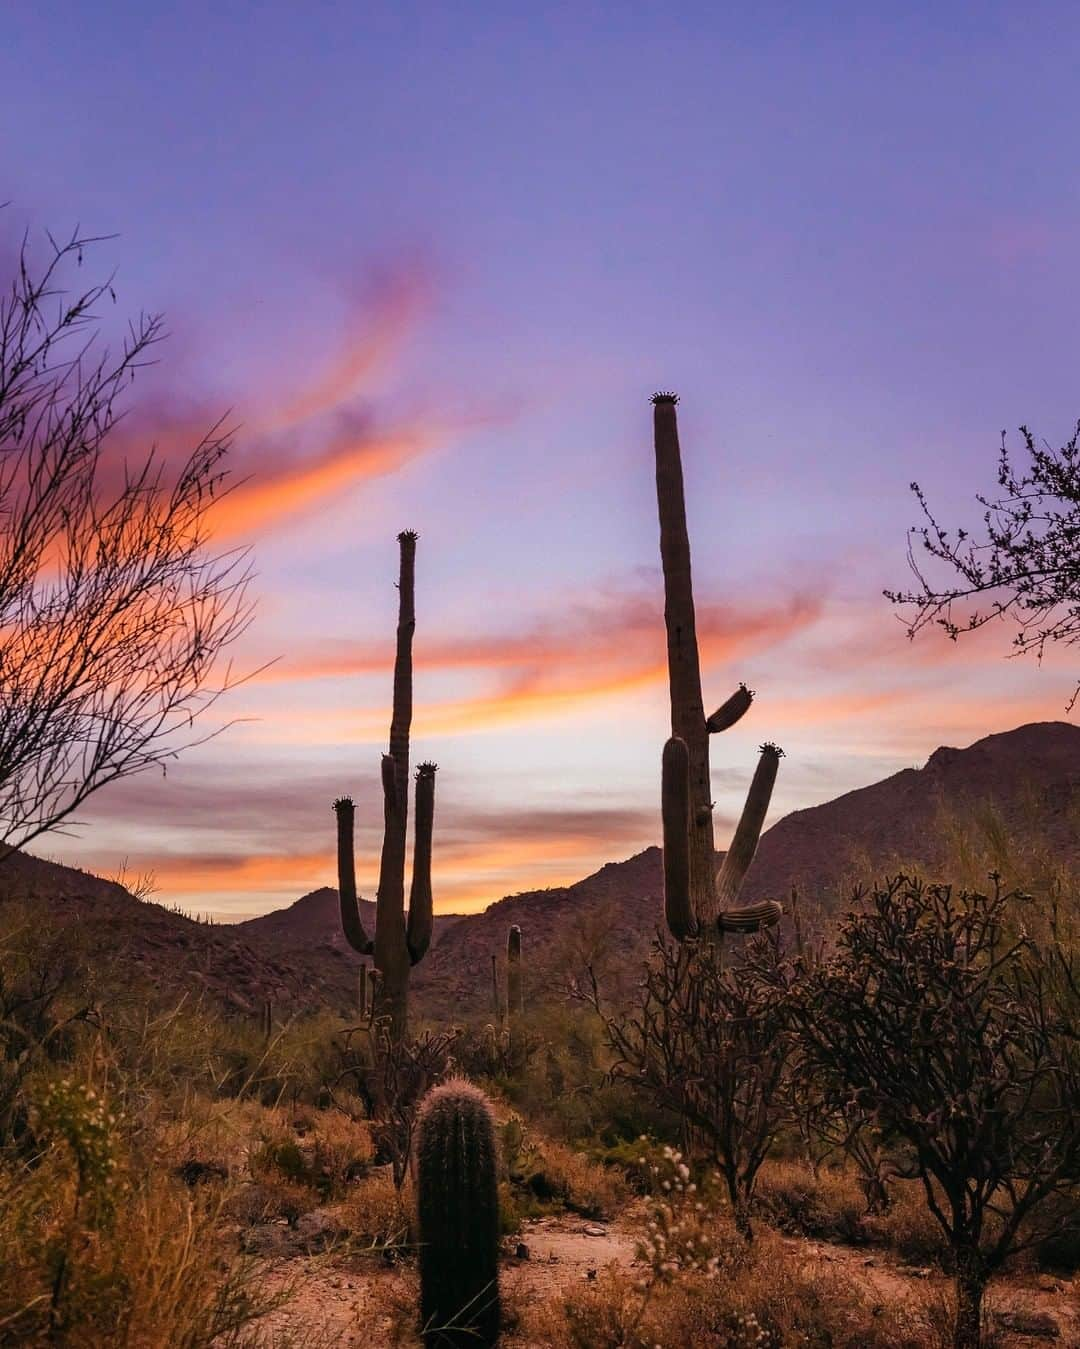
[{"left": 0, "top": 1077, "right": 275, "bottom": 1349}]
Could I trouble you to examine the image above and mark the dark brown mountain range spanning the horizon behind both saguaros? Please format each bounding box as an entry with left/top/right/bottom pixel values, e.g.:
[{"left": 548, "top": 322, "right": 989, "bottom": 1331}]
[{"left": 0, "top": 722, "right": 1080, "bottom": 1018}]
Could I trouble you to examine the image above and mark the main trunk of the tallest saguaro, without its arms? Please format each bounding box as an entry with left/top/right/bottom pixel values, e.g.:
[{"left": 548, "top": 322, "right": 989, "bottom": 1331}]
[{"left": 653, "top": 395, "right": 717, "bottom": 927}]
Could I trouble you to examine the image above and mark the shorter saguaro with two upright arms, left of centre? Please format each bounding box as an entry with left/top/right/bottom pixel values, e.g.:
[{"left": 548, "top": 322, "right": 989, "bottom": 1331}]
[{"left": 334, "top": 530, "right": 436, "bottom": 1041}]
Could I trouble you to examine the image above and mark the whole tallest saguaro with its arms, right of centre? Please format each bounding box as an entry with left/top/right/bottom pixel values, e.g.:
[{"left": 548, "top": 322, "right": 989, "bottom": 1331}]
[{"left": 653, "top": 393, "right": 781, "bottom": 940}]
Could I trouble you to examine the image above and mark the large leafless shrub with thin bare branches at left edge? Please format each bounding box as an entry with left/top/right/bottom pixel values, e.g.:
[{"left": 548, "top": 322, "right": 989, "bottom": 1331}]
[{"left": 0, "top": 221, "right": 251, "bottom": 858}]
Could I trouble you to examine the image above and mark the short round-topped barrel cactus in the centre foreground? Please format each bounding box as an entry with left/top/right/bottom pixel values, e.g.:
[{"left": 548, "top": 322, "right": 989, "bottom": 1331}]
[{"left": 417, "top": 1078, "right": 500, "bottom": 1349}]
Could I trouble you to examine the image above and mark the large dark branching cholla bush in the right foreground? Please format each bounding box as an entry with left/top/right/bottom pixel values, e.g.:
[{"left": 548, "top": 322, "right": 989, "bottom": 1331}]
[{"left": 791, "top": 877, "right": 1080, "bottom": 1349}]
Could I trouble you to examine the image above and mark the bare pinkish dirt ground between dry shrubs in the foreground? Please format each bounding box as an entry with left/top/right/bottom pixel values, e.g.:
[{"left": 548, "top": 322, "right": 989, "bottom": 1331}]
[{"left": 246, "top": 1209, "right": 1080, "bottom": 1349}]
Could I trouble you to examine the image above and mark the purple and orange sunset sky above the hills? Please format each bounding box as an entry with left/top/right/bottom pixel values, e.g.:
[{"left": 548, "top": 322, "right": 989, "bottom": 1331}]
[{"left": 0, "top": 0, "right": 1080, "bottom": 919}]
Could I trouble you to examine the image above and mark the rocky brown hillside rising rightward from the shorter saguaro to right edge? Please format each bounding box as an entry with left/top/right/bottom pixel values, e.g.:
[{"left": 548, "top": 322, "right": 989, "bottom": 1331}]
[{"left": 415, "top": 722, "right": 1080, "bottom": 1010}]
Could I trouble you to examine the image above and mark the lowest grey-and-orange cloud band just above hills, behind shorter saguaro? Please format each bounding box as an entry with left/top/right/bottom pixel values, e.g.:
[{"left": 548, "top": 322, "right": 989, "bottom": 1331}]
[{"left": 80, "top": 762, "right": 658, "bottom": 912}]
